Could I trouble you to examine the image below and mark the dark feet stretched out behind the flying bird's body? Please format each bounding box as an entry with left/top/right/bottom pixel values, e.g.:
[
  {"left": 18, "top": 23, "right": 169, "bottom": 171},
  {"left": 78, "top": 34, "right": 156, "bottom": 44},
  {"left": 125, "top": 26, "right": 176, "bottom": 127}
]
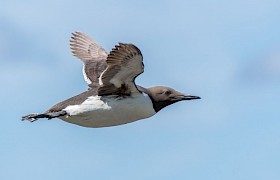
[{"left": 21, "top": 111, "right": 67, "bottom": 122}]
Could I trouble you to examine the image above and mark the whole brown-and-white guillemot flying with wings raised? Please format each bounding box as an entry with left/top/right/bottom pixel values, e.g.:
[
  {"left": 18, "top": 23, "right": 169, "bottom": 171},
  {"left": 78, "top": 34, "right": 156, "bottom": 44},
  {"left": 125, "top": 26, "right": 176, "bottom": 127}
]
[{"left": 22, "top": 32, "right": 200, "bottom": 128}]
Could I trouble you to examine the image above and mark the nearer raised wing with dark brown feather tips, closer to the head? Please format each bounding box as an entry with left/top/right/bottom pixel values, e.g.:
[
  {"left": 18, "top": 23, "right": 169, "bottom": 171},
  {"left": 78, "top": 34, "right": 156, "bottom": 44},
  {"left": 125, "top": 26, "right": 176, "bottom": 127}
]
[{"left": 98, "top": 43, "right": 144, "bottom": 95}]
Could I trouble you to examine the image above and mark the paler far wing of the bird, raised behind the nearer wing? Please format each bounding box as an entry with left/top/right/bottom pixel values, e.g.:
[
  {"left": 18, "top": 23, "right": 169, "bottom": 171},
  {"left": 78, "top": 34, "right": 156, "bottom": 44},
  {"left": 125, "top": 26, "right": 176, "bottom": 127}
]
[{"left": 70, "top": 32, "right": 108, "bottom": 87}]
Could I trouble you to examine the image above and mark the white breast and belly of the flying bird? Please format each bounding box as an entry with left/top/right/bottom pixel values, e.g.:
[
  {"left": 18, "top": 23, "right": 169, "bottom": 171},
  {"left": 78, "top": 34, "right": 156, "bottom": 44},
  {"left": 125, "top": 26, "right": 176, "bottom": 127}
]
[{"left": 61, "top": 94, "right": 156, "bottom": 127}]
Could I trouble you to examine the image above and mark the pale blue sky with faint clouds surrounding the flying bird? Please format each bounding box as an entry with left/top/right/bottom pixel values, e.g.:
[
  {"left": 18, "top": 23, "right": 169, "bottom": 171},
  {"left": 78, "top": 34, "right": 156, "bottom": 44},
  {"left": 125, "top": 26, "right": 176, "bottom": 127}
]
[{"left": 0, "top": 0, "right": 280, "bottom": 180}]
